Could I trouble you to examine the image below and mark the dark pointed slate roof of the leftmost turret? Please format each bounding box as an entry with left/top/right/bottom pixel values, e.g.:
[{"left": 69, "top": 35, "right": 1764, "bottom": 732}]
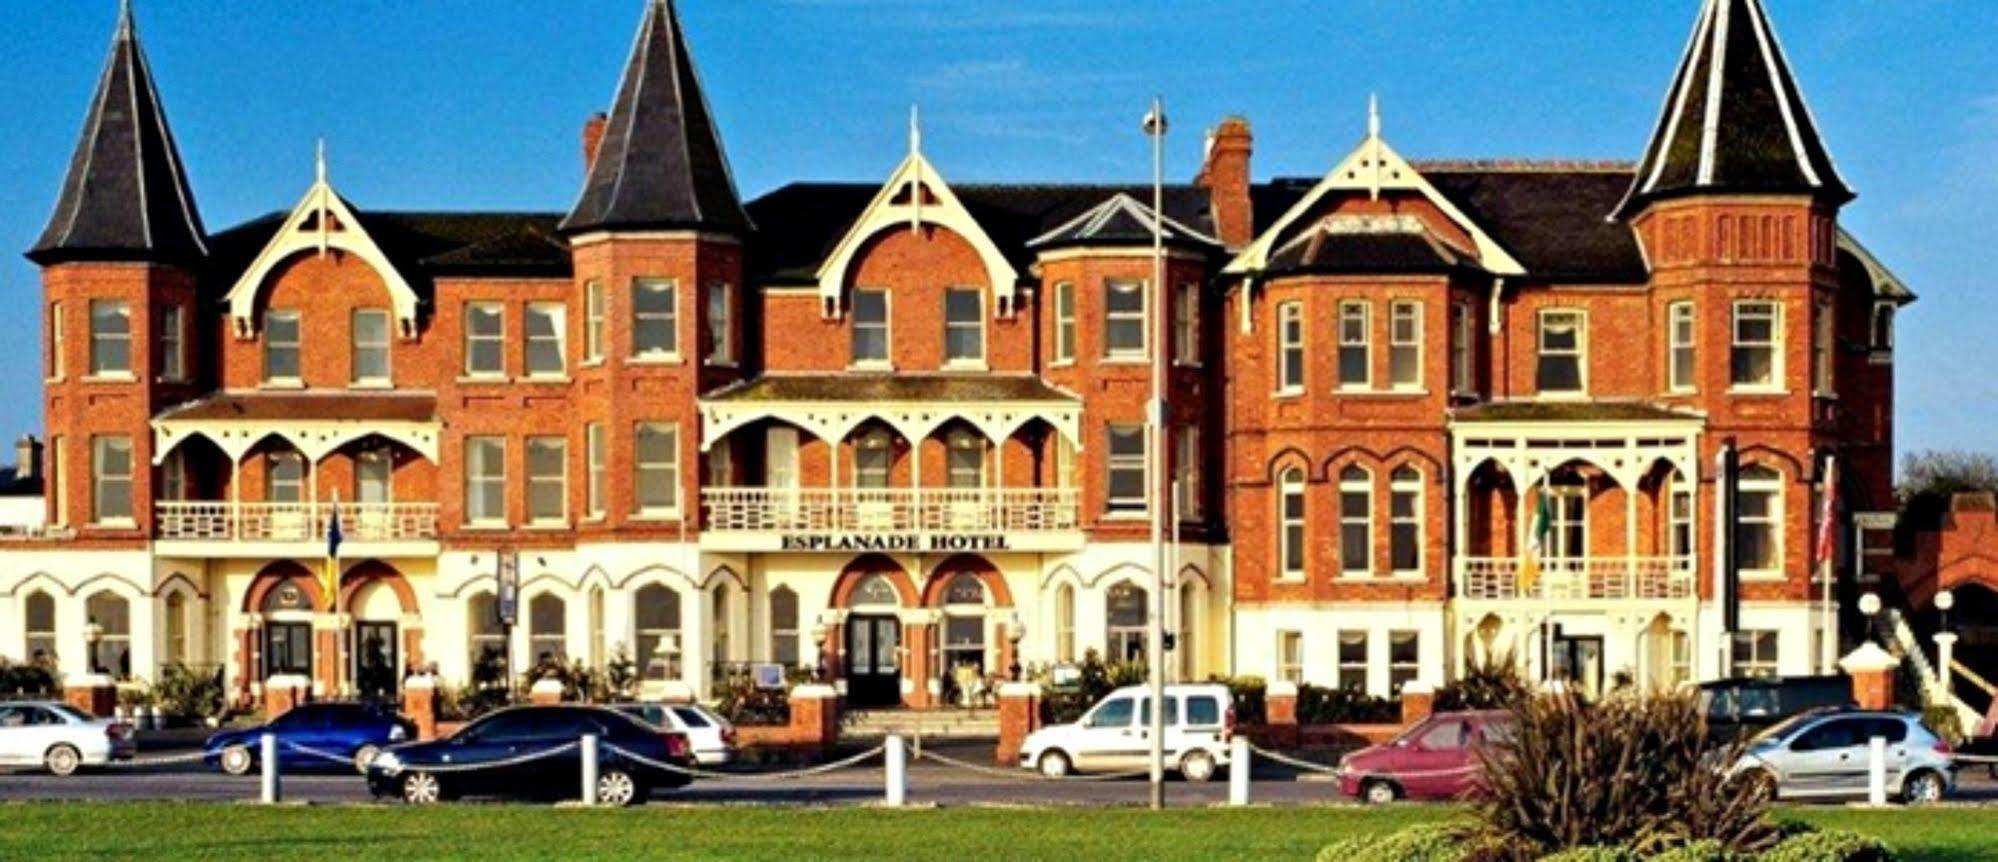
[{"left": 28, "top": 4, "right": 208, "bottom": 266}]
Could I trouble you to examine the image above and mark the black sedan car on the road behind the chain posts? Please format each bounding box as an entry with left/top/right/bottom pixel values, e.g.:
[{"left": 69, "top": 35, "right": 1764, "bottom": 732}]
[{"left": 368, "top": 704, "right": 693, "bottom": 806}]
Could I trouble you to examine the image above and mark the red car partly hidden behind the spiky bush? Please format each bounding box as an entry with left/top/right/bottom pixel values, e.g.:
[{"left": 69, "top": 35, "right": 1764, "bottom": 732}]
[{"left": 1339, "top": 712, "right": 1512, "bottom": 804}]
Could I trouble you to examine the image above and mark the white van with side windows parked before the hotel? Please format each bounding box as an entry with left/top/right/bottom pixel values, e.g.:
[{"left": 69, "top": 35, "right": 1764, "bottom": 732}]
[{"left": 1019, "top": 684, "right": 1235, "bottom": 782}]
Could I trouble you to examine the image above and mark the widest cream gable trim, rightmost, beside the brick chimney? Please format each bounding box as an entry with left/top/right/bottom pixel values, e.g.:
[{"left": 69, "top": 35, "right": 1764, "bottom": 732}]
[{"left": 1223, "top": 104, "right": 1526, "bottom": 276}]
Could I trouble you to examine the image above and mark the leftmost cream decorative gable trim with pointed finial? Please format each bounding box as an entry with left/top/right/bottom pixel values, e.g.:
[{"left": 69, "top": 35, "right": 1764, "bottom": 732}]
[{"left": 224, "top": 146, "right": 416, "bottom": 340}]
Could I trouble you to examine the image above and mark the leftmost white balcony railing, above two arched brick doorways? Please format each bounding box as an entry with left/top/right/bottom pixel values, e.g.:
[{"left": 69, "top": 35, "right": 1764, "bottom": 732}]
[{"left": 152, "top": 500, "right": 438, "bottom": 542}]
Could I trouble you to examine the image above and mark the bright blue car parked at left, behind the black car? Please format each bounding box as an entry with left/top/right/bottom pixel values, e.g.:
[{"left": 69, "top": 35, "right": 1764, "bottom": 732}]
[{"left": 204, "top": 702, "right": 416, "bottom": 776}]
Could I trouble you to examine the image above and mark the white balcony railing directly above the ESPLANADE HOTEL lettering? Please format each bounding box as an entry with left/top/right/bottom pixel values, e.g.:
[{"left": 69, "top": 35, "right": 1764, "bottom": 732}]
[{"left": 701, "top": 488, "right": 1079, "bottom": 534}]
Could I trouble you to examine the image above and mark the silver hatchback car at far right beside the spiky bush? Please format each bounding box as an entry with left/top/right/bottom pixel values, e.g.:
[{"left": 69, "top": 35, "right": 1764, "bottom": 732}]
[{"left": 1734, "top": 710, "right": 1956, "bottom": 804}]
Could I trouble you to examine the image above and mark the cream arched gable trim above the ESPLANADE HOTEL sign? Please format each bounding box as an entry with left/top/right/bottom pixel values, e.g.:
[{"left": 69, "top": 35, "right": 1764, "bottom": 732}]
[{"left": 819, "top": 114, "right": 1019, "bottom": 318}]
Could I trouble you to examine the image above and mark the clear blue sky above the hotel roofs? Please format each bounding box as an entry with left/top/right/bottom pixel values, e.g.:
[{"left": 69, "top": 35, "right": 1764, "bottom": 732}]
[{"left": 0, "top": 0, "right": 1998, "bottom": 466}]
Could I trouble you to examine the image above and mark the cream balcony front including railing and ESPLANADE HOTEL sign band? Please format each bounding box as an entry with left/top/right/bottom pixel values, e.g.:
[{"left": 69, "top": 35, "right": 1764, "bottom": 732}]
[{"left": 701, "top": 488, "right": 1083, "bottom": 552}]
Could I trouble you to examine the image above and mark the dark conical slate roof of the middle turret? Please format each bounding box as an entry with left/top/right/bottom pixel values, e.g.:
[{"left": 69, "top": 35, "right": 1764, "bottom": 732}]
[{"left": 561, "top": 0, "right": 751, "bottom": 234}]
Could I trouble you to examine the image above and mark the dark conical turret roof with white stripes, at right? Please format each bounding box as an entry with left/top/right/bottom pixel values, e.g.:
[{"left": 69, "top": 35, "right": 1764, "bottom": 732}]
[{"left": 1616, "top": 0, "right": 1852, "bottom": 218}]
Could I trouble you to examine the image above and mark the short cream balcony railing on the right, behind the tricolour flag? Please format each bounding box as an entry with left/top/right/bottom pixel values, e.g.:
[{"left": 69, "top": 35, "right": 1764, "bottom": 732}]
[{"left": 1457, "top": 556, "right": 1694, "bottom": 602}]
